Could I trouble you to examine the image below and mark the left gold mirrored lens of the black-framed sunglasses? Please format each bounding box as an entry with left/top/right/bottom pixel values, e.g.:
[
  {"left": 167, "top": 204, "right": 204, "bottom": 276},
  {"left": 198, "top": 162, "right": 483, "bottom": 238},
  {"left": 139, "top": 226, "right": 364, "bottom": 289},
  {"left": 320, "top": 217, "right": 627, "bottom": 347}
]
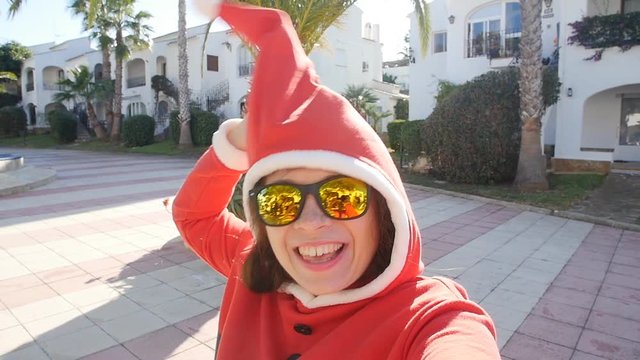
[{"left": 257, "top": 185, "right": 302, "bottom": 225}]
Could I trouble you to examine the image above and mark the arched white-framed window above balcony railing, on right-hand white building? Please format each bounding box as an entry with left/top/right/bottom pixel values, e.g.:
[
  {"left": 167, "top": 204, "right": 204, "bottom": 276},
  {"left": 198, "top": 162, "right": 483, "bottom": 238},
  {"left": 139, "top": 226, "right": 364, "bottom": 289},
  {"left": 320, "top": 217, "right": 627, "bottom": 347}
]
[{"left": 467, "top": 2, "right": 522, "bottom": 58}]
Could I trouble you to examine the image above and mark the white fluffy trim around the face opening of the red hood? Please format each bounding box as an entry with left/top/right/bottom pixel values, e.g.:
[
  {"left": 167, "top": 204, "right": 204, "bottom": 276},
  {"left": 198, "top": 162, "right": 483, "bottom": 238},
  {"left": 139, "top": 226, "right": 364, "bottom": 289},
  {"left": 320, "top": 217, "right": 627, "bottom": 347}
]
[{"left": 242, "top": 150, "right": 410, "bottom": 309}]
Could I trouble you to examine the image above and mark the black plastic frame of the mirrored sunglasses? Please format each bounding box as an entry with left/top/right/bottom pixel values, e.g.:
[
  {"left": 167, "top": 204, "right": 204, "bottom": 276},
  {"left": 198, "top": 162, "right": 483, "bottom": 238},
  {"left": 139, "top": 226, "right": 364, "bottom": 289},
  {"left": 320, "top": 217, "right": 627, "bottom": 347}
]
[{"left": 249, "top": 175, "right": 371, "bottom": 227}]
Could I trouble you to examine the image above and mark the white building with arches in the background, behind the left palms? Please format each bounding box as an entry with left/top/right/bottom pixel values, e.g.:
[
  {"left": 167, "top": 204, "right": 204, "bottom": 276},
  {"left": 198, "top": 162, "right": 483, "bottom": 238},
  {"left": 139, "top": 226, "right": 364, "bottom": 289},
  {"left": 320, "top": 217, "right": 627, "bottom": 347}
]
[{"left": 22, "top": 6, "right": 399, "bottom": 135}]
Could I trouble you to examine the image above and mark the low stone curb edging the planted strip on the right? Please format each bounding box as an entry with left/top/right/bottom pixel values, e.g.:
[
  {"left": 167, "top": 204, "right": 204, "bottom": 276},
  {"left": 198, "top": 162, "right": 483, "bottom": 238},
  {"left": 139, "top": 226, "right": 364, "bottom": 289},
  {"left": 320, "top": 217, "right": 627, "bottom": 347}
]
[{"left": 404, "top": 183, "right": 640, "bottom": 232}]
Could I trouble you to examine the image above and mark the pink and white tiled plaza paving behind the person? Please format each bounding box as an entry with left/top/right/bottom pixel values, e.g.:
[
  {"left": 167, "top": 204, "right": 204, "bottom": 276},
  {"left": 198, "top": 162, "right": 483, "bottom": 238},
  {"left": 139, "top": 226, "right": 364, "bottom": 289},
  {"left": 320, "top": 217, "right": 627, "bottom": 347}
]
[{"left": 0, "top": 148, "right": 640, "bottom": 360}]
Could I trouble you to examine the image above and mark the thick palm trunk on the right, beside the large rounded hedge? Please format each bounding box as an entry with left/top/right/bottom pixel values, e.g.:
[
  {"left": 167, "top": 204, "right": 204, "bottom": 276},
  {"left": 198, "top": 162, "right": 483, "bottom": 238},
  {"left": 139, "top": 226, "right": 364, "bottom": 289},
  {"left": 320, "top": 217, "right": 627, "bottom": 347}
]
[{"left": 514, "top": 0, "right": 549, "bottom": 191}]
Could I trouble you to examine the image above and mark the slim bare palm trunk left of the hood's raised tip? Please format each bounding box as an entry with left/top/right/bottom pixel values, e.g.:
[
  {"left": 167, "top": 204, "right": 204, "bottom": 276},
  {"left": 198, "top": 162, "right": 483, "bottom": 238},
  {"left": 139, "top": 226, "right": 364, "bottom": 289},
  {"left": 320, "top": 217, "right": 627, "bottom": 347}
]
[{"left": 178, "top": 0, "right": 193, "bottom": 149}]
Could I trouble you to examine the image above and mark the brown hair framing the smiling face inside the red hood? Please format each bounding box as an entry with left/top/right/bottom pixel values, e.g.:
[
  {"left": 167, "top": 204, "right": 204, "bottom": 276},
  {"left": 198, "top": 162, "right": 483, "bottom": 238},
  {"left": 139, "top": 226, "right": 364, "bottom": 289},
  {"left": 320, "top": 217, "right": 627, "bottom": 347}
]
[{"left": 242, "top": 186, "right": 396, "bottom": 293}]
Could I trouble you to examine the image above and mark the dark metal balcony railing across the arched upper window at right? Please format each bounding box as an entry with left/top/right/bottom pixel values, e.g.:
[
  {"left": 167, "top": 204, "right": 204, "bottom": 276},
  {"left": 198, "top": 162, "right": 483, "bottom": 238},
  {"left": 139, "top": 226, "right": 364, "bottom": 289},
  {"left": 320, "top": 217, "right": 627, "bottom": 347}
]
[{"left": 467, "top": 31, "right": 521, "bottom": 59}]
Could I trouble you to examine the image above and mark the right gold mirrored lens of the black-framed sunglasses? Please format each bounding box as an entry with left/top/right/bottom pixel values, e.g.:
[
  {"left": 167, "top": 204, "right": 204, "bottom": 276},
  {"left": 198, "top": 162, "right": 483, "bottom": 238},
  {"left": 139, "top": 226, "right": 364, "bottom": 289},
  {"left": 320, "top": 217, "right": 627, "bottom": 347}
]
[{"left": 319, "top": 178, "right": 367, "bottom": 219}]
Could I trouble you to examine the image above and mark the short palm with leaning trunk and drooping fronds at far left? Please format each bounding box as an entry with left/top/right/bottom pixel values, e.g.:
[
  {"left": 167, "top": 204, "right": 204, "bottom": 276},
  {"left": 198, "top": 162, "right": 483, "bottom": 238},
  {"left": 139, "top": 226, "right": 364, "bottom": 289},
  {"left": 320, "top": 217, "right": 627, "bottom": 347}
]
[{"left": 53, "top": 65, "right": 110, "bottom": 140}]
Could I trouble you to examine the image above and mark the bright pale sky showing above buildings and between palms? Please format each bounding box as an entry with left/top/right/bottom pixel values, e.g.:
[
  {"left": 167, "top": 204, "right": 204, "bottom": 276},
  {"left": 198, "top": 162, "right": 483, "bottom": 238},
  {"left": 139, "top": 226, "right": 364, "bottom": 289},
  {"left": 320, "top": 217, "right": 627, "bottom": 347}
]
[{"left": 0, "top": 0, "right": 413, "bottom": 61}]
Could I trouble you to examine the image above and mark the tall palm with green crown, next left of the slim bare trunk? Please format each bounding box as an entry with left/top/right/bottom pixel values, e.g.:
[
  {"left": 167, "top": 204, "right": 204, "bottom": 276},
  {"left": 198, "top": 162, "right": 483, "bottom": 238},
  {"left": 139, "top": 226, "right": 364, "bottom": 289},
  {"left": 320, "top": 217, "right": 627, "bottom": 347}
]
[{"left": 100, "top": 0, "right": 151, "bottom": 142}]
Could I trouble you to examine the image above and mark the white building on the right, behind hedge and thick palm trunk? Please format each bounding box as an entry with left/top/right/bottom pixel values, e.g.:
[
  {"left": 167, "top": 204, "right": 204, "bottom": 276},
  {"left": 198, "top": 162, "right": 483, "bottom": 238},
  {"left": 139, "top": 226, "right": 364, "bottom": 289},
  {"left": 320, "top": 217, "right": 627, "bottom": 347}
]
[{"left": 409, "top": 0, "right": 640, "bottom": 171}]
